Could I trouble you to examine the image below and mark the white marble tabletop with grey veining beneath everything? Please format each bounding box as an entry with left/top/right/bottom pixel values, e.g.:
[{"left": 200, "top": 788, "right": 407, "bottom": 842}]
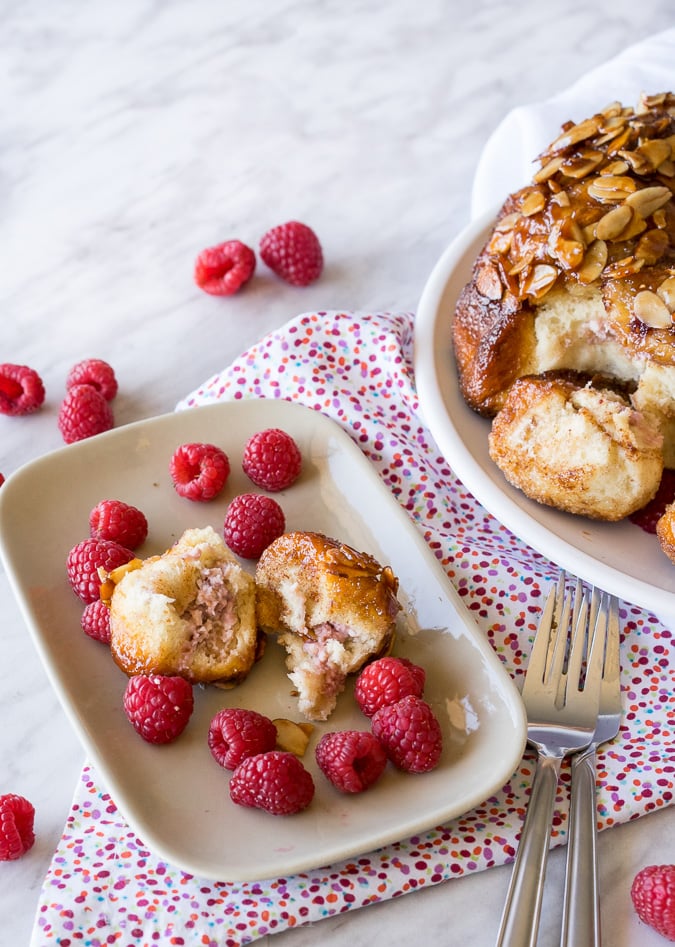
[{"left": 0, "top": 0, "right": 675, "bottom": 947}]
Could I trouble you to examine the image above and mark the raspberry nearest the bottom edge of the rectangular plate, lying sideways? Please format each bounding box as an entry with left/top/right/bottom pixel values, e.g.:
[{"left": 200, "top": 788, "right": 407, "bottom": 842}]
[{"left": 230, "top": 750, "right": 314, "bottom": 815}]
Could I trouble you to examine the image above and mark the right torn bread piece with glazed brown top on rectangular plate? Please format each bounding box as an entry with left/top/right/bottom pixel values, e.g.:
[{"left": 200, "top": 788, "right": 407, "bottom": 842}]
[{"left": 255, "top": 531, "right": 400, "bottom": 720}]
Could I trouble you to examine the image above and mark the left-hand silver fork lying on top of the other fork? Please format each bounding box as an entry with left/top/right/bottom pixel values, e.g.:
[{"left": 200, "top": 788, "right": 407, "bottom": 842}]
[{"left": 497, "top": 573, "right": 607, "bottom": 947}]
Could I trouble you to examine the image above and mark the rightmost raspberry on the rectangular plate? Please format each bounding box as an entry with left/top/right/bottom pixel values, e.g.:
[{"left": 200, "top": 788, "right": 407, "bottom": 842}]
[{"left": 372, "top": 694, "right": 443, "bottom": 773}]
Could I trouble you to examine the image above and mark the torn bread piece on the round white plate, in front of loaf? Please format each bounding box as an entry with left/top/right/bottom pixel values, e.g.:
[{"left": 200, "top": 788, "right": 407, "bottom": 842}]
[{"left": 489, "top": 372, "right": 663, "bottom": 521}]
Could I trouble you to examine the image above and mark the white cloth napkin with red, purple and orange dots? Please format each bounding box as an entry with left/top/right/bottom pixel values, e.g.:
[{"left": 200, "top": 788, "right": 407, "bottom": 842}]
[{"left": 33, "top": 312, "right": 675, "bottom": 947}]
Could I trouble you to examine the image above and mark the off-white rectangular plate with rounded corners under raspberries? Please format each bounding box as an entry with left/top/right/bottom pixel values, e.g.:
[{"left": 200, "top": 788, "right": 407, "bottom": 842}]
[{"left": 0, "top": 400, "right": 525, "bottom": 881}]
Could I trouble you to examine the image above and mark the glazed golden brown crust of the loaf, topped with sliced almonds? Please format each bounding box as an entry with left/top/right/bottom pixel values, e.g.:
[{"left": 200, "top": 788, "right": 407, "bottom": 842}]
[{"left": 453, "top": 93, "right": 675, "bottom": 416}]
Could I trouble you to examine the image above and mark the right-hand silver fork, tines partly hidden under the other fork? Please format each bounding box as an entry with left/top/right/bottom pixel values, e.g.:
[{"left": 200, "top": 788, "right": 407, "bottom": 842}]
[{"left": 560, "top": 591, "right": 622, "bottom": 947}]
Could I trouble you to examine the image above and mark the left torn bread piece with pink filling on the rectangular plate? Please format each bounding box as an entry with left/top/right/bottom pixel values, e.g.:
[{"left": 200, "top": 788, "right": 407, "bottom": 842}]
[{"left": 110, "top": 526, "right": 258, "bottom": 684}]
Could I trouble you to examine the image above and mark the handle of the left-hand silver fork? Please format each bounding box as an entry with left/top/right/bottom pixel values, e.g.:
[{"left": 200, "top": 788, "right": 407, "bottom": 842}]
[{"left": 497, "top": 755, "right": 562, "bottom": 947}]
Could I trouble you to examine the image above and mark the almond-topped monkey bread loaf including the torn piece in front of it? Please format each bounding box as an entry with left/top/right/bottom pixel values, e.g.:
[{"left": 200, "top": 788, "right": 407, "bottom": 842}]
[{"left": 452, "top": 93, "right": 675, "bottom": 519}]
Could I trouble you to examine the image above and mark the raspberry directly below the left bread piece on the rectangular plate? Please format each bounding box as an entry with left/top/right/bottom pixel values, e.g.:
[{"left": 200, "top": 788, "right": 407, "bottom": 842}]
[{"left": 124, "top": 674, "right": 194, "bottom": 743}]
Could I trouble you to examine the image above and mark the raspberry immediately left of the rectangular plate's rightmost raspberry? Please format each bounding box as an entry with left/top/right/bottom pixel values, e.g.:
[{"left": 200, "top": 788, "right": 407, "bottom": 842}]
[{"left": 315, "top": 730, "right": 387, "bottom": 793}]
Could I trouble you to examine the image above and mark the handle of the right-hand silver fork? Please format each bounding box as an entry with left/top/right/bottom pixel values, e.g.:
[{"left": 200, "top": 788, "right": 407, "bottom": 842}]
[{"left": 560, "top": 746, "right": 600, "bottom": 947}]
